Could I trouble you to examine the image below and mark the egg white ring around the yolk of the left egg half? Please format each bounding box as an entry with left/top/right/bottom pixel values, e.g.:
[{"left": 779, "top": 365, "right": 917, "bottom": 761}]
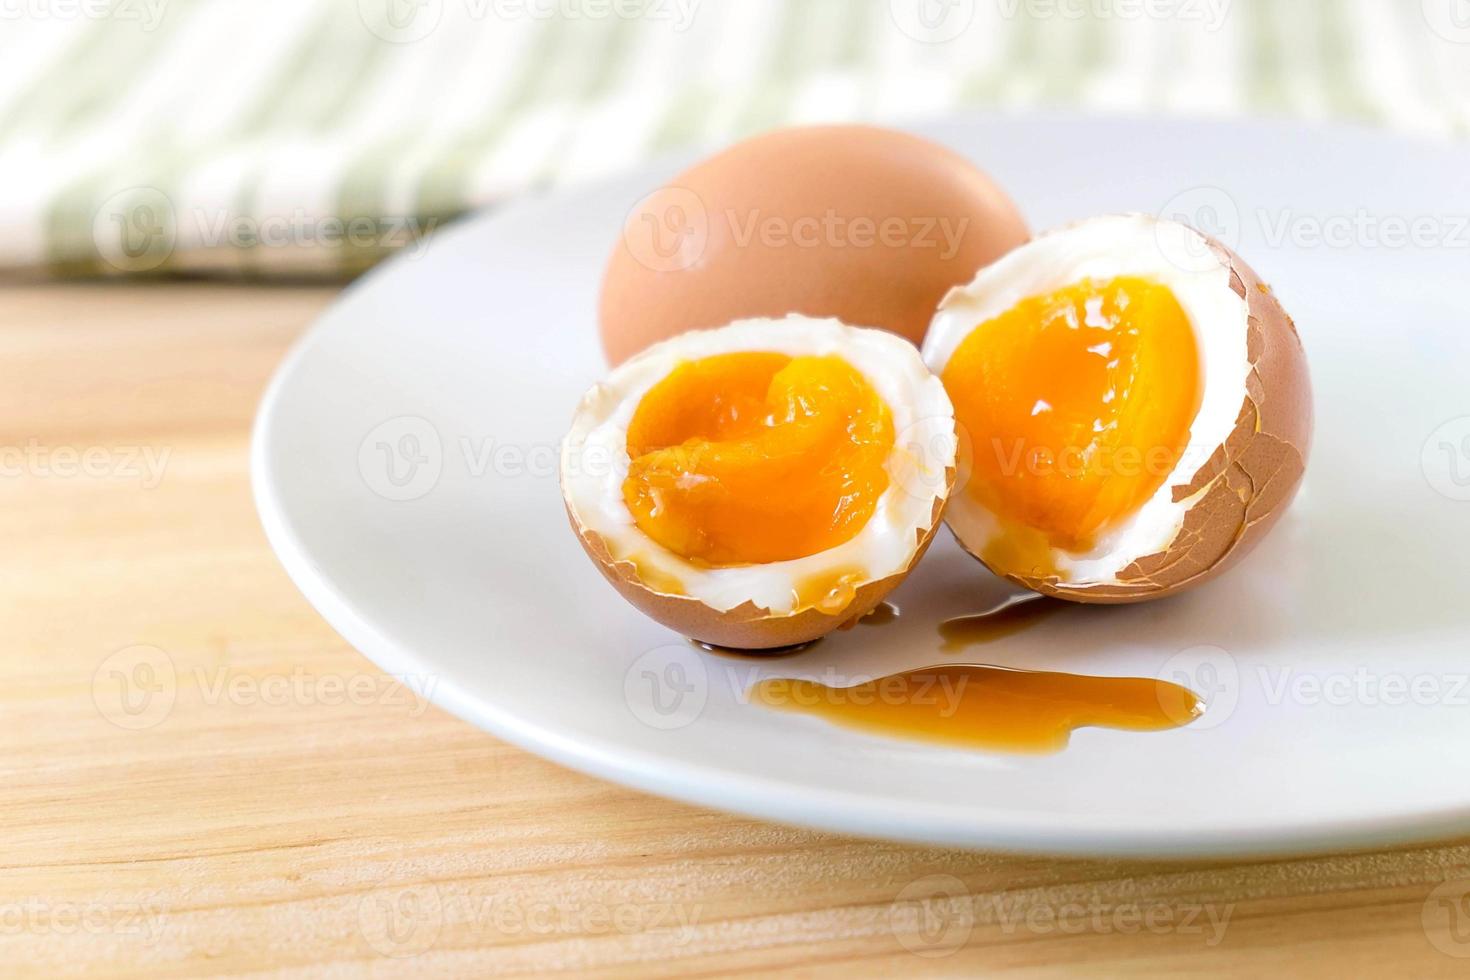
[{"left": 562, "top": 314, "right": 956, "bottom": 616}]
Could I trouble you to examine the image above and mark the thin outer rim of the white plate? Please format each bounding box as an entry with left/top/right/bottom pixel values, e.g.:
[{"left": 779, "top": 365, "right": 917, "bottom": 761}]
[{"left": 248, "top": 112, "right": 1470, "bottom": 860}]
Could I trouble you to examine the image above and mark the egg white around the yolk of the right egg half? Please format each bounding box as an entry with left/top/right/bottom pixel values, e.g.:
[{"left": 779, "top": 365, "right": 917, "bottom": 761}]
[{"left": 923, "top": 215, "right": 1251, "bottom": 588}]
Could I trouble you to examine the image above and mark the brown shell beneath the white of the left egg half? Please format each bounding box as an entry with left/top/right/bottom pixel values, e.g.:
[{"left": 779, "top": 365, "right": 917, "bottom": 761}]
[{"left": 567, "top": 467, "right": 956, "bottom": 649}]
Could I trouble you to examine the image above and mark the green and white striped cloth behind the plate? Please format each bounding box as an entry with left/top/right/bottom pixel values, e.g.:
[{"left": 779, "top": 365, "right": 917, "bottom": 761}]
[{"left": 0, "top": 0, "right": 1470, "bottom": 278}]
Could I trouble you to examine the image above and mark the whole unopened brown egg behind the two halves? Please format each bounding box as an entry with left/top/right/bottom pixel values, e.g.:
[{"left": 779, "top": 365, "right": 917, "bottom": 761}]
[{"left": 600, "top": 126, "right": 1029, "bottom": 366}]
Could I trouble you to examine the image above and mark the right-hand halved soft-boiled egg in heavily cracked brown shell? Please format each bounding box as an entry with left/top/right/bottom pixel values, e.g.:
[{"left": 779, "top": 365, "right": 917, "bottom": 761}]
[{"left": 923, "top": 215, "right": 1311, "bottom": 602}]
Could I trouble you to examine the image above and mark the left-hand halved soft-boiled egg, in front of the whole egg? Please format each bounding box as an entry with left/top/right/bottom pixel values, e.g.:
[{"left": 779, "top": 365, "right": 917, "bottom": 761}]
[{"left": 562, "top": 316, "right": 957, "bottom": 649}]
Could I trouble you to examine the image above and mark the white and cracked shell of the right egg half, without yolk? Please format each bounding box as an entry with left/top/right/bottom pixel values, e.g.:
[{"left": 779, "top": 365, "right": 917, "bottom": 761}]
[{"left": 925, "top": 215, "right": 1313, "bottom": 604}]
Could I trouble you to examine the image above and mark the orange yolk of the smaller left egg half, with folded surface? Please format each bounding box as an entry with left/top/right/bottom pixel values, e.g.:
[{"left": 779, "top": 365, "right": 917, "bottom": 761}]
[{"left": 622, "top": 351, "right": 894, "bottom": 566}]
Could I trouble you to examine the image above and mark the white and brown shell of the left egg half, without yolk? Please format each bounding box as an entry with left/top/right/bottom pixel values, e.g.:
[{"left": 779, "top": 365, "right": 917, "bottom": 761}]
[{"left": 562, "top": 316, "right": 957, "bottom": 649}]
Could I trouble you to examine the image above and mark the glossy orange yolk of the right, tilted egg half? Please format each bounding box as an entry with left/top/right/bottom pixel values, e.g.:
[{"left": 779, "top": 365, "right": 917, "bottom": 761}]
[{"left": 942, "top": 276, "right": 1201, "bottom": 572}]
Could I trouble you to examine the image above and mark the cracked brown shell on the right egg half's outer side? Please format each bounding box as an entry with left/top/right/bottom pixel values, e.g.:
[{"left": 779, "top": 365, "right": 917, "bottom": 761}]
[{"left": 960, "top": 232, "right": 1313, "bottom": 604}]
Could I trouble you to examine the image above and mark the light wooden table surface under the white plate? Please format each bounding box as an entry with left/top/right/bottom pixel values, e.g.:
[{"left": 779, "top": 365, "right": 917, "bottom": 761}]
[{"left": 0, "top": 284, "right": 1470, "bottom": 977}]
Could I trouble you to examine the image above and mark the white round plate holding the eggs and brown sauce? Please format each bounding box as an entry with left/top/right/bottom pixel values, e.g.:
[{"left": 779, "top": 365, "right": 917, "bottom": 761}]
[{"left": 253, "top": 118, "right": 1470, "bottom": 855}]
